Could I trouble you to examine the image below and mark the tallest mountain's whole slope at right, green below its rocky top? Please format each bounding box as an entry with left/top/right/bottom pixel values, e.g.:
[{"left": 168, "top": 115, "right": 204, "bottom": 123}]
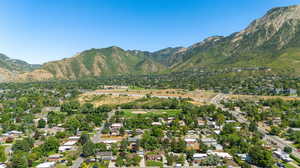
[{"left": 172, "top": 6, "right": 300, "bottom": 72}]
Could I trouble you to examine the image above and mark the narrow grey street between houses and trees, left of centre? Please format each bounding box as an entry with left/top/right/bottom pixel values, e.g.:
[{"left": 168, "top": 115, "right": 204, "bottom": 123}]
[{"left": 71, "top": 110, "right": 116, "bottom": 168}]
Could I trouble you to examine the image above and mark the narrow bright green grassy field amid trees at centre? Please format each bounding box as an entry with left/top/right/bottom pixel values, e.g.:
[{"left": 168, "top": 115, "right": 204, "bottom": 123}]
[{"left": 122, "top": 109, "right": 181, "bottom": 118}]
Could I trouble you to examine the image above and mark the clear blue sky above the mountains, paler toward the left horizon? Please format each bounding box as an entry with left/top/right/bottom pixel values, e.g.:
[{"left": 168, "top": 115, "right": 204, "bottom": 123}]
[{"left": 0, "top": 0, "right": 300, "bottom": 64}]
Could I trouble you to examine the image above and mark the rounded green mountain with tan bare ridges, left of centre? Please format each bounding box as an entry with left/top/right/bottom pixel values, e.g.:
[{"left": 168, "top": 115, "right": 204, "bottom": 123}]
[{"left": 42, "top": 46, "right": 165, "bottom": 79}]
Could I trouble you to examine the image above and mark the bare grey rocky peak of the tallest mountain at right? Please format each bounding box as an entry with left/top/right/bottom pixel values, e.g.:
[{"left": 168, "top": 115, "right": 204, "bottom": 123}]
[{"left": 232, "top": 5, "right": 300, "bottom": 49}]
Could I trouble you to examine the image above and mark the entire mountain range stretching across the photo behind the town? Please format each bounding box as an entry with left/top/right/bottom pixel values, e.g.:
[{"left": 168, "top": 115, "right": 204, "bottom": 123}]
[{"left": 0, "top": 5, "right": 300, "bottom": 81}]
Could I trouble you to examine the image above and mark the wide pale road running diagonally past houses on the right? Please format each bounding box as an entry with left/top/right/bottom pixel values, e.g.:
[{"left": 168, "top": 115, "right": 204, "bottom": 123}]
[{"left": 211, "top": 94, "right": 300, "bottom": 158}]
